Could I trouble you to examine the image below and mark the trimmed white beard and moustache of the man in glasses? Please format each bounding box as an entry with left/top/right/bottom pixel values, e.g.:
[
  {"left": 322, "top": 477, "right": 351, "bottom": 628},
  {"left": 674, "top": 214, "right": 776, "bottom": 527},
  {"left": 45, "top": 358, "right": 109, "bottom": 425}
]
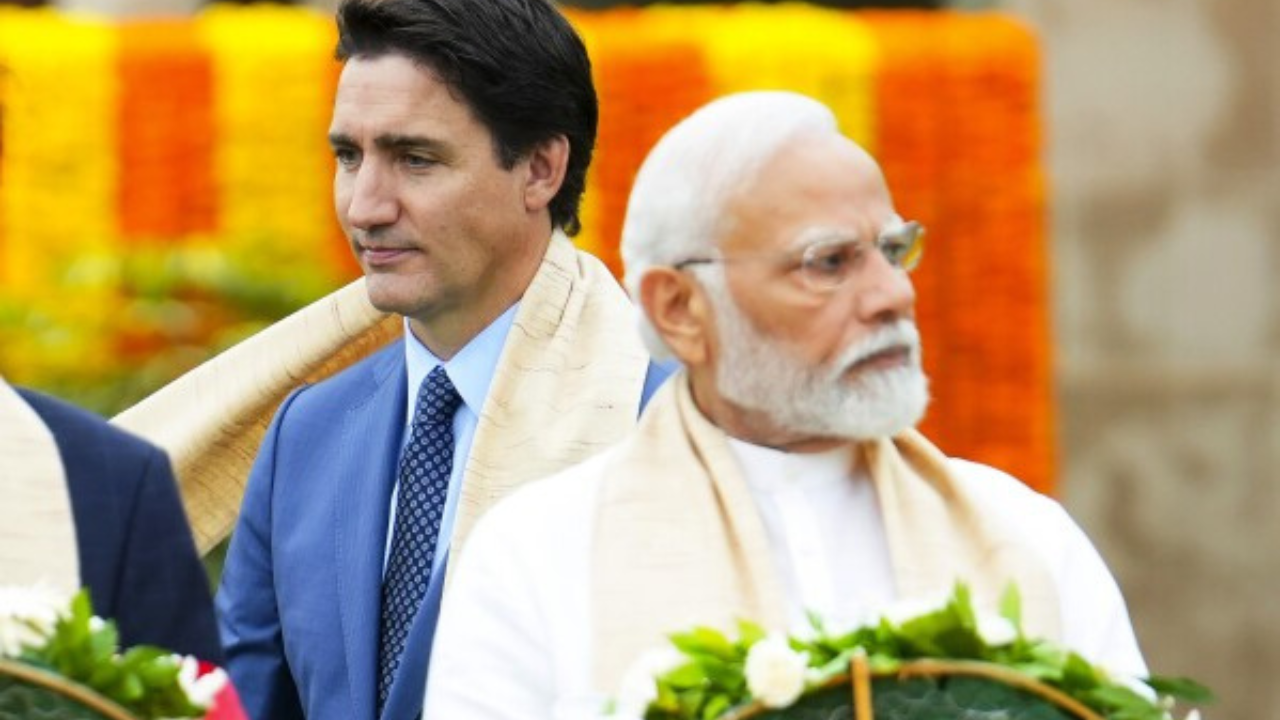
[{"left": 708, "top": 279, "right": 929, "bottom": 441}]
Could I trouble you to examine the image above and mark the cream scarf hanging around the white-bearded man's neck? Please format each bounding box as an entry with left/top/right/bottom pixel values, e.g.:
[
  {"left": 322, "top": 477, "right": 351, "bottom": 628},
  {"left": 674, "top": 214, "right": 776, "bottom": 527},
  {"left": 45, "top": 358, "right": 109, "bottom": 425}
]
[{"left": 591, "top": 374, "right": 1060, "bottom": 689}]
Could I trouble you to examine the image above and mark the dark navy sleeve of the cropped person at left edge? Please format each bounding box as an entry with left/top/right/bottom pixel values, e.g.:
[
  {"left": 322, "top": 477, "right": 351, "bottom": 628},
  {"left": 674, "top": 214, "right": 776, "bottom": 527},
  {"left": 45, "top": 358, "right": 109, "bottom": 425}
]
[{"left": 115, "top": 448, "right": 223, "bottom": 665}]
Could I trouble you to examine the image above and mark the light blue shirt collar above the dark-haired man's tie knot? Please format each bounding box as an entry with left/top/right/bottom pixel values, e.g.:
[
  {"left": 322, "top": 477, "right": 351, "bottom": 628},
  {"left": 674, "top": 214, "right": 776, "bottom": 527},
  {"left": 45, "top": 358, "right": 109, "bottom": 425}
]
[{"left": 404, "top": 302, "right": 520, "bottom": 425}]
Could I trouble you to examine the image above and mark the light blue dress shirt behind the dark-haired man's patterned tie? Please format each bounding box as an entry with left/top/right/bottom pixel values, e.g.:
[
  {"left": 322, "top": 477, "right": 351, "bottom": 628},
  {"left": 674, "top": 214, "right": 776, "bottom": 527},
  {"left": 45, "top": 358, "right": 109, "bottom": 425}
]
[{"left": 383, "top": 302, "right": 520, "bottom": 577}]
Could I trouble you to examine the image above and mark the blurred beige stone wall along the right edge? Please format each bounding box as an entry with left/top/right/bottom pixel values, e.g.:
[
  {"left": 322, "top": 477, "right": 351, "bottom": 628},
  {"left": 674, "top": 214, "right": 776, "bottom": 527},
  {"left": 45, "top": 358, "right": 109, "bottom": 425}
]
[{"left": 1005, "top": 0, "right": 1280, "bottom": 720}]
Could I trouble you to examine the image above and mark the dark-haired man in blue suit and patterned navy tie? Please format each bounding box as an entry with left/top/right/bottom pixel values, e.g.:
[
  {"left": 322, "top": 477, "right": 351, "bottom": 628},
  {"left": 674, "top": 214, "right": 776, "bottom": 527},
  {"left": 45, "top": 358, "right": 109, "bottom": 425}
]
[{"left": 218, "top": 0, "right": 666, "bottom": 720}]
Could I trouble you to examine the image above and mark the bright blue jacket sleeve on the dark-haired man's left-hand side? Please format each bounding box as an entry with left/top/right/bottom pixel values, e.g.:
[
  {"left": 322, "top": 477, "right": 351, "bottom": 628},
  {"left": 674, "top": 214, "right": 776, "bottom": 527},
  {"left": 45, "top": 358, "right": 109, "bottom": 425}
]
[{"left": 218, "top": 395, "right": 303, "bottom": 720}]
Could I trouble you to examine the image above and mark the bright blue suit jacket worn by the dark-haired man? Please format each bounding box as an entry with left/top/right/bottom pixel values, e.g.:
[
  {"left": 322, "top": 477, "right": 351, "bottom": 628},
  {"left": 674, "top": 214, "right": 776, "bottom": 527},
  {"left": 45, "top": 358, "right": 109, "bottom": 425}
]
[{"left": 218, "top": 341, "right": 669, "bottom": 720}]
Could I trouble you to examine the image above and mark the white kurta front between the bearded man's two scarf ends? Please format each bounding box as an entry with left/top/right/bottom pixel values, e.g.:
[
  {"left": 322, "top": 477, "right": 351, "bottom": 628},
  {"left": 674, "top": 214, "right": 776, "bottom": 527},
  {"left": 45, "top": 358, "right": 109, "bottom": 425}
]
[{"left": 728, "top": 438, "right": 897, "bottom": 630}]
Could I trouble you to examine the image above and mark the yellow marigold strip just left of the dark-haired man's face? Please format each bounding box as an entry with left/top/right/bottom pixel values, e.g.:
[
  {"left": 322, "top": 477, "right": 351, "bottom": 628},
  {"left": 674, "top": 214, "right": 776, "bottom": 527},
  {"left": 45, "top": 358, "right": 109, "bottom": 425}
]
[{"left": 196, "top": 5, "right": 348, "bottom": 275}]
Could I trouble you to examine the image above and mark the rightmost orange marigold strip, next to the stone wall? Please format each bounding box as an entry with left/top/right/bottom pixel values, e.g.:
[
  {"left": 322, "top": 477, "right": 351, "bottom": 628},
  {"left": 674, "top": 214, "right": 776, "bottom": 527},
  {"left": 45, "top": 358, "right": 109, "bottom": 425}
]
[{"left": 901, "top": 14, "right": 1053, "bottom": 492}]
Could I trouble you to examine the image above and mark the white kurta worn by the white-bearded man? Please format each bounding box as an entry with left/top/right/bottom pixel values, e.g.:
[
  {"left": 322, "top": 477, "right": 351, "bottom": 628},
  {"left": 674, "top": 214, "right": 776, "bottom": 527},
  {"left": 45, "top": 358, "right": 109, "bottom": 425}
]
[{"left": 424, "top": 442, "right": 1146, "bottom": 720}]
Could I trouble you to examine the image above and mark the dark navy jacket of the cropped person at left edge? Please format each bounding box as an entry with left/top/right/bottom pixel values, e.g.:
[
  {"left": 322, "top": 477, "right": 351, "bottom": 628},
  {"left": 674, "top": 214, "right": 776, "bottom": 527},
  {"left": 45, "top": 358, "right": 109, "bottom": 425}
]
[{"left": 18, "top": 389, "right": 223, "bottom": 665}]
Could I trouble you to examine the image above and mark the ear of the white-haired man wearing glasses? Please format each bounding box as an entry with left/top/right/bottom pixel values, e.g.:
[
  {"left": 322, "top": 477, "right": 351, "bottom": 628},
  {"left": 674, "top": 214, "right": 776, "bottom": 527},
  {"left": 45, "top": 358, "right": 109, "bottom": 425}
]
[{"left": 639, "top": 266, "right": 714, "bottom": 369}]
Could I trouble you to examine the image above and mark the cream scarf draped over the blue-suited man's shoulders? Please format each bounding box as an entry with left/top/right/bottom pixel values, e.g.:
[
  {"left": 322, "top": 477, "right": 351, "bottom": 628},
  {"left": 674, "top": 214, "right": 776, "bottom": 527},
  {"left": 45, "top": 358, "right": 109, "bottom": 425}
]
[{"left": 113, "top": 232, "right": 649, "bottom": 552}]
